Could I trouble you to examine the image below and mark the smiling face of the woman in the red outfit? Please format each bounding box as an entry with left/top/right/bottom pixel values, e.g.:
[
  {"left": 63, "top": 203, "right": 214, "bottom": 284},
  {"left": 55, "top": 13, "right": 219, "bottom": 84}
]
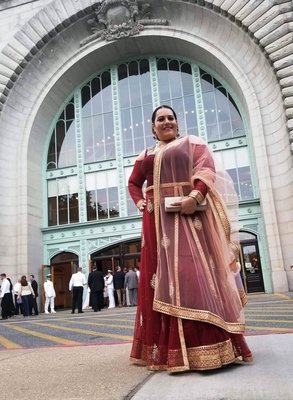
[{"left": 152, "top": 108, "right": 178, "bottom": 142}]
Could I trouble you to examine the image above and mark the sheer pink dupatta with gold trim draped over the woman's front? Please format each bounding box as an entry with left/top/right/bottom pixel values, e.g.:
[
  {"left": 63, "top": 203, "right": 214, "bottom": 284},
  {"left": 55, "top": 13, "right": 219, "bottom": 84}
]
[{"left": 153, "top": 136, "right": 245, "bottom": 334}]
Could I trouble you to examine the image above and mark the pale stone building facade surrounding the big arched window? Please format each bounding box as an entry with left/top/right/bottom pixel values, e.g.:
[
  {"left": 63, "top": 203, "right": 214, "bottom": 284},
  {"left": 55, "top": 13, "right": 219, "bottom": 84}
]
[{"left": 0, "top": 0, "right": 293, "bottom": 291}]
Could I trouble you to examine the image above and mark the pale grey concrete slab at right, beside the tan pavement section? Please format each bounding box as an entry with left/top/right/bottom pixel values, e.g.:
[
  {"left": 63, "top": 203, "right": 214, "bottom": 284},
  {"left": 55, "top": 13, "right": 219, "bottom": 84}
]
[{"left": 132, "top": 334, "right": 293, "bottom": 400}]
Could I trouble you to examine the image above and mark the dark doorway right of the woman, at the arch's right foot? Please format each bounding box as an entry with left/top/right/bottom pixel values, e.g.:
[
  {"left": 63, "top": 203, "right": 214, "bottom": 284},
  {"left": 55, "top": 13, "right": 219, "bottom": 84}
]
[{"left": 240, "top": 232, "right": 264, "bottom": 293}]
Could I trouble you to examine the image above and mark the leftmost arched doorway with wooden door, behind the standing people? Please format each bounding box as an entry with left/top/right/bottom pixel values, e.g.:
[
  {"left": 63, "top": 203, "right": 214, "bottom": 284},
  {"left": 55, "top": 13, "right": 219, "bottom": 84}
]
[{"left": 42, "top": 252, "right": 78, "bottom": 309}]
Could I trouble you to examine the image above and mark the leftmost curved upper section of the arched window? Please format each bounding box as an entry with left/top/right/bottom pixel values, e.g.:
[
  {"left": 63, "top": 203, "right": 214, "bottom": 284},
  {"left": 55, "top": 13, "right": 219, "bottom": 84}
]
[{"left": 47, "top": 98, "right": 76, "bottom": 169}]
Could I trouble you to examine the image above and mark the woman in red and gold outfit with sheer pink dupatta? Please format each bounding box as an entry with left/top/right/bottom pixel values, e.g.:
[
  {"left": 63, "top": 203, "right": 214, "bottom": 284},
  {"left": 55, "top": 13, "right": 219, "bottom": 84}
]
[{"left": 128, "top": 106, "right": 252, "bottom": 372}]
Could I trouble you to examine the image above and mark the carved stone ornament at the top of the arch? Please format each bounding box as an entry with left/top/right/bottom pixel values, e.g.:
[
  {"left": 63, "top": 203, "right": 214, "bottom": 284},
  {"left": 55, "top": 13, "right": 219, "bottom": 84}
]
[{"left": 80, "top": 0, "right": 168, "bottom": 46}]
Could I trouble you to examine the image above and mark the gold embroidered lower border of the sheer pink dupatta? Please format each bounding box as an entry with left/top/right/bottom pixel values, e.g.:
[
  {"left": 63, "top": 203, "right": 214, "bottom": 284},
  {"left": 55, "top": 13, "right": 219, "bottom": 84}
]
[{"left": 153, "top": 299, "right": 245, "bottom": 334}]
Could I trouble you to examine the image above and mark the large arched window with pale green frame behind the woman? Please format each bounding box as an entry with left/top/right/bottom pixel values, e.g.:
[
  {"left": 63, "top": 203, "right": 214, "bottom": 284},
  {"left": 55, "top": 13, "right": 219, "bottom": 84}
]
[{"left": 47, "top": 57, "right": 254, "bottom": 226}]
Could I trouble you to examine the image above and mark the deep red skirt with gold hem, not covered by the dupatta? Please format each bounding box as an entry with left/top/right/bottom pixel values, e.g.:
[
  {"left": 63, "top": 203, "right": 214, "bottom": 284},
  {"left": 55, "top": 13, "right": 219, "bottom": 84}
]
[{"left": 130, "top": 195, "right": 252, "bottom": 372}]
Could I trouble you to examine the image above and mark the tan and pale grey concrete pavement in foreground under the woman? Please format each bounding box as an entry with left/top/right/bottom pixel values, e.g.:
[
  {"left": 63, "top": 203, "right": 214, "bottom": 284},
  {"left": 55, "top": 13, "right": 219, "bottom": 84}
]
[{"left": 0, "top": 334, "right": 293, "bottom": 400}]
